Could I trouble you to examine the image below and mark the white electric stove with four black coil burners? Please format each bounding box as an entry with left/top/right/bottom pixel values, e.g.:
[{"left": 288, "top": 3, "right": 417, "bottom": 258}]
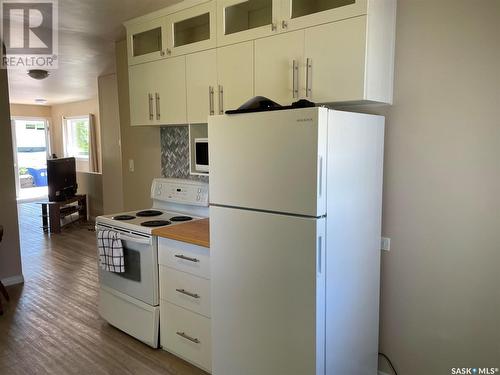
[{"left": 96, "top": 178, "right": 209, "bottom": 348}]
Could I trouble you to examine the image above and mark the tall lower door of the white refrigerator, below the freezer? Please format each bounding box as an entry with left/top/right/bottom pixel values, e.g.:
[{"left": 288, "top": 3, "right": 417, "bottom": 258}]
[{"left": 210, "top": 207, "right": 325, "bottom": 375}]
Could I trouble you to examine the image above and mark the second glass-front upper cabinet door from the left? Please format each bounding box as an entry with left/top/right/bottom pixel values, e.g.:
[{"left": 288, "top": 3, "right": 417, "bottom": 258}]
[{"left": 166, "top": 0, "right": 216, "bottom": 56}]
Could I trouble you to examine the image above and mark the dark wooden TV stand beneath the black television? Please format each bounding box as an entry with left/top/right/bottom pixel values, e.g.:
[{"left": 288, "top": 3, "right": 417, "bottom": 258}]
[{"left": 39, "top": 194, "right": 87, "bottom": 233}]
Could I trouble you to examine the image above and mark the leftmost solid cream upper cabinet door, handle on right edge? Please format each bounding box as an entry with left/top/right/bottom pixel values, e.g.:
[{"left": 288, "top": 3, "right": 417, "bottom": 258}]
[{"left": 128, "top": 63, "right": 155, "bottom": 126}]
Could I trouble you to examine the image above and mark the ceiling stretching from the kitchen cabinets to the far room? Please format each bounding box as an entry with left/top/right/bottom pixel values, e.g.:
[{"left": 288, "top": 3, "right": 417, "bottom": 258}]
[{"left": 5, "top": 0, "right": 180, "bottom": 105}]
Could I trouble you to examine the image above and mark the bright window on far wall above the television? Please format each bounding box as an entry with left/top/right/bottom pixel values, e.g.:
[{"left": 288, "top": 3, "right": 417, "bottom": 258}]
[{"left": 64, "top": 116, "right": 90, "bottom": 159}]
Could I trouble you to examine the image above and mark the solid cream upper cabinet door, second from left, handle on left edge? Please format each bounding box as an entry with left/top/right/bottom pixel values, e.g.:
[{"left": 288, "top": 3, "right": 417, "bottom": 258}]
[{"left": 154, "top": 56, "right": 187, "bottom": 125}]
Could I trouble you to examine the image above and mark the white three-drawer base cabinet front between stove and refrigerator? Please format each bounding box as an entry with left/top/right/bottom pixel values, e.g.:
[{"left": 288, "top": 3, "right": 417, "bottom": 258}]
[{"left": 158, "top": 238, "right": 212, "bottom": 372}]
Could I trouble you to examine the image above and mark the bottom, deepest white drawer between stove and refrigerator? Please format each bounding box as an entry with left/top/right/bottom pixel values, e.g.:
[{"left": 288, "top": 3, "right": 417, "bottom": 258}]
[{"left": 160, "top": 301, "right": 212, "bottom": 372}]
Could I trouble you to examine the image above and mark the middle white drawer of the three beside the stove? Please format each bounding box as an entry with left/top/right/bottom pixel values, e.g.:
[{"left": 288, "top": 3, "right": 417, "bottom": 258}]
[{"left": 160, "top": 266, "right": 210, "bottom": 317}]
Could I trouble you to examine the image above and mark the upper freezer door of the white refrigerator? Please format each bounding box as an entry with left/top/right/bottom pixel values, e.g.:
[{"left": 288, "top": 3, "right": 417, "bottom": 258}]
[{"left": 208, "top": 108, "right": 328, "bottom": 217}]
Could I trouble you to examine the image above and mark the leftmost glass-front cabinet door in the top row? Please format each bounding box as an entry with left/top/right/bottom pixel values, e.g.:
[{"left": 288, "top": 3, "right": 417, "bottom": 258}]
[{"left": 127, "top": 18, "right": 167, "bottom": 65}]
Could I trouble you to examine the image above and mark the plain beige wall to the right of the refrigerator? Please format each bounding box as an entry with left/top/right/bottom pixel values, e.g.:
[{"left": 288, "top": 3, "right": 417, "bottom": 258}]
[{"left": 364, "top": 0, "right": 500, "bottom": 375}]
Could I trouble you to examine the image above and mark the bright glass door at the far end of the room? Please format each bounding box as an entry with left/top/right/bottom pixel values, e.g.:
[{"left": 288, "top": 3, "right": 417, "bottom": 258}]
[{"left": 12, "top": 117, "right": 50, "bottom": 202}]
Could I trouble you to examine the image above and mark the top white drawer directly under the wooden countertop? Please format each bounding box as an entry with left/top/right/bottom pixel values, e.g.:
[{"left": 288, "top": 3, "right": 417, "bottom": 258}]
[{"left": 158, "top": 238, "right": 210, "bottom": 279}]
